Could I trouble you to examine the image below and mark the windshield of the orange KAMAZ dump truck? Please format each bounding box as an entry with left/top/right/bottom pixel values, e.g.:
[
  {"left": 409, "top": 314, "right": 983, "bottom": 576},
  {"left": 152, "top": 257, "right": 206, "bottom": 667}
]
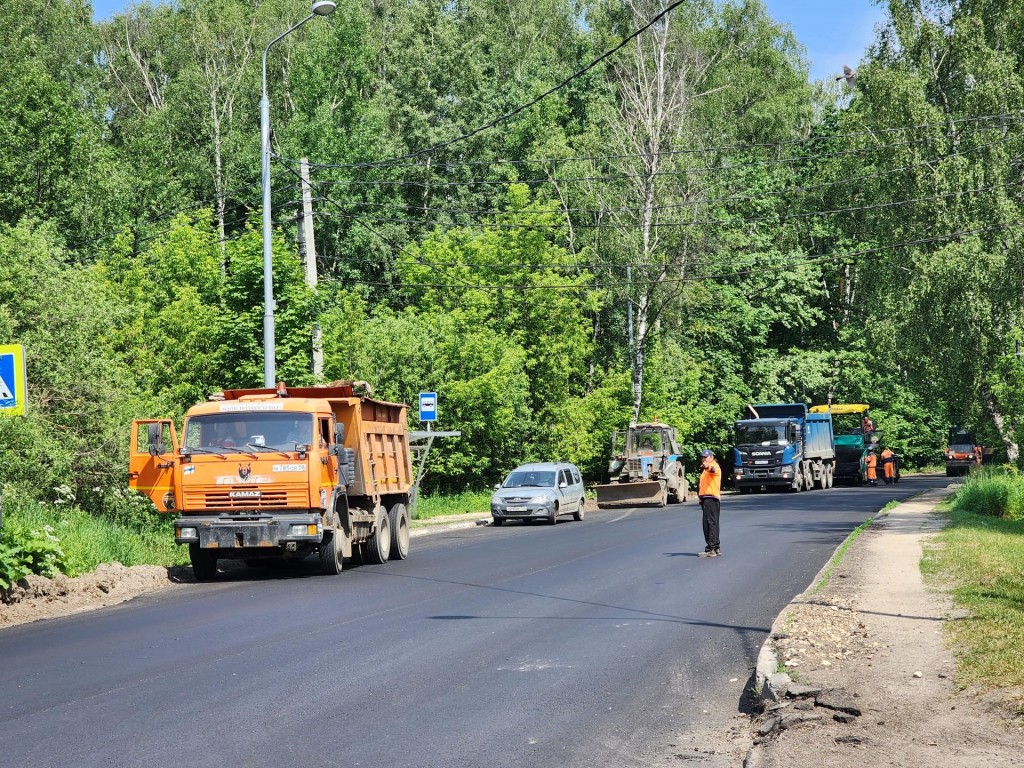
[{"left": 184, "top": 412, "right": 313, "bottom": 453}]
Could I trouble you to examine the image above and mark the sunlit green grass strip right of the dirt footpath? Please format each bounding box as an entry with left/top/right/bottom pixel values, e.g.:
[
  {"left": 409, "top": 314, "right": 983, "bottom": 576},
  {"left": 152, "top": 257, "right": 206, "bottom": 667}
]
[{"left": 921, "top": 475, "right": 1024, "bottom": 714}]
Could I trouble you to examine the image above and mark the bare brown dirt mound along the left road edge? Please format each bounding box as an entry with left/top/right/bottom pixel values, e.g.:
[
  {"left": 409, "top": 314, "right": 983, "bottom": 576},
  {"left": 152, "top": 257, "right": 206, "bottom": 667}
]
[{"left": 0, "top": 562, "right": 191, "bottom": 628}]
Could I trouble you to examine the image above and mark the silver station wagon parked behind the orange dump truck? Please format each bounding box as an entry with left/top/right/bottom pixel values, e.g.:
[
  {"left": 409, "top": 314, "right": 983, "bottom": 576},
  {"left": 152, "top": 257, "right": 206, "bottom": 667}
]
[{"left": 490, "top": 462, "right": 586, "bottom": 525}]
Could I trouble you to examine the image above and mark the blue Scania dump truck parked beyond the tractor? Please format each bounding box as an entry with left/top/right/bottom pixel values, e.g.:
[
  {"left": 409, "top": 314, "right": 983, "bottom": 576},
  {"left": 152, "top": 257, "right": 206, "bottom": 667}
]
[{"left": 732, "top": 402, "right": 836, "bottom": 494}]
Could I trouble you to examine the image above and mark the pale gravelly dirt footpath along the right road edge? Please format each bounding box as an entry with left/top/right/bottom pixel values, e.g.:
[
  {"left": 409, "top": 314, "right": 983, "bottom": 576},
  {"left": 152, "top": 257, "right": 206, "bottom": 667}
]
[{"left": 745, "top": 489, "right": 1022, "bottom": 768}]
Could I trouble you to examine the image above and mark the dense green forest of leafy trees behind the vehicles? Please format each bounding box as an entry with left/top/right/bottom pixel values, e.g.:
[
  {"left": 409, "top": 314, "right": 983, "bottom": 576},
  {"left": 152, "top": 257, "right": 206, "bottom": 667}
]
[{"left": 0, "top": 0, "right": 1024, "bottom": 528}]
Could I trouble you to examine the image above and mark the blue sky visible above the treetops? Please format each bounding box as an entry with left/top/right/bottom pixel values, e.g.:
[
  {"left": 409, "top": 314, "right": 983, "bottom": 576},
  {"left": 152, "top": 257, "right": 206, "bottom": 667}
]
[{"left": 93, "top": 0, "right": 884, "bottom": 79}]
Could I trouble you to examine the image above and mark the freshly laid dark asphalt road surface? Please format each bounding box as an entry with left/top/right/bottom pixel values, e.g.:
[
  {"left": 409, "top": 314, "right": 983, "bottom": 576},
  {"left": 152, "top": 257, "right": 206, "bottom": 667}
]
[{"left": 0, "top": 476, "right": 947, "bottom": 768}]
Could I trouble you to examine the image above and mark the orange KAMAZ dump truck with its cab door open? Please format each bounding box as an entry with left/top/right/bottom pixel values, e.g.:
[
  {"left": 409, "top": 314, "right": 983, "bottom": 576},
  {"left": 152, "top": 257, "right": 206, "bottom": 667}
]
[{"left": 129, "top": 382, "right": 413, "bottom": 581}]
